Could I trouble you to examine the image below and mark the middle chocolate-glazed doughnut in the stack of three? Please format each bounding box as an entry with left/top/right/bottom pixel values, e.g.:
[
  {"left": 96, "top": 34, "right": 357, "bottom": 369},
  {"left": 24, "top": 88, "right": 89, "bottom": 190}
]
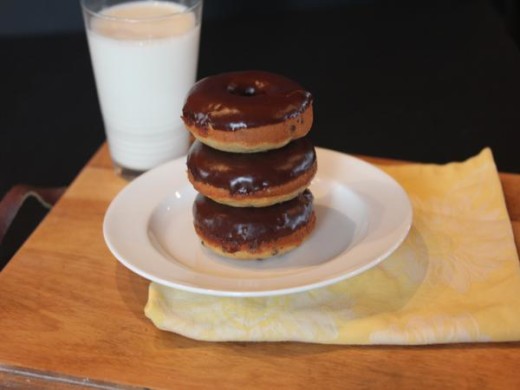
[{"left": 187, "top": 137, "right": 317, "bottom": 207}]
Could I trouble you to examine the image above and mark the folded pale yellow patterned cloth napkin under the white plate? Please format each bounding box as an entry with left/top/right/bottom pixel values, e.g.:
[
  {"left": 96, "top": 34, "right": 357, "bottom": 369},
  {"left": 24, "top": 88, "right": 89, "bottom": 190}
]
[{"left": 145, "top": 149, "right": 520, "bottom": 344}]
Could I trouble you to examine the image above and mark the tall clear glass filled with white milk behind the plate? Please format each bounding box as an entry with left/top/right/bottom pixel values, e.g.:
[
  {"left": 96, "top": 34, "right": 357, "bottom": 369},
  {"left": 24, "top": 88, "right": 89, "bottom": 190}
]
[{"left": 81, "top": 0, "right": 202, "bottom": 179}]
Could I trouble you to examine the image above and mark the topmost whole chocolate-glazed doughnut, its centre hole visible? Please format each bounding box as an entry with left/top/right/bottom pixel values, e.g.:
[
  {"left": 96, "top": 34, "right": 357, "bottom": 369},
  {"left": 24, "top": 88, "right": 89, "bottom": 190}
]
[{"left": 182, "top": 71, "right": 313, "bottom": 153}]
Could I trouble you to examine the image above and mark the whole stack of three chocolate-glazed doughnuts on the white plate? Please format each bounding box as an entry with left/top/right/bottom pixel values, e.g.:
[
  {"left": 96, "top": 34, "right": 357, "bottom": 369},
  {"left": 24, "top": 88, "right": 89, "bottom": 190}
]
[{"left": 182, "top": 71, "right": 317, "bottom": 259}]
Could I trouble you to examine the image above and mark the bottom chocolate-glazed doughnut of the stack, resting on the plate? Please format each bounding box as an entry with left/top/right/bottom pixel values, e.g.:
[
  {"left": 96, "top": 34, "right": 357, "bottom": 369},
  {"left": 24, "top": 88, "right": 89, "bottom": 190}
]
[{"left": 193, "top": 190, "right": 316, "bottom": 260}]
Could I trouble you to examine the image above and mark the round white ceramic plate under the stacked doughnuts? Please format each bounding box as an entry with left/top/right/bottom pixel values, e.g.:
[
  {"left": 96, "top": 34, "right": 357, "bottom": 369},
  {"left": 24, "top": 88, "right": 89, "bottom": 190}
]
[{"left": 103, "top": 148, "right": 412, "bottom": 297}]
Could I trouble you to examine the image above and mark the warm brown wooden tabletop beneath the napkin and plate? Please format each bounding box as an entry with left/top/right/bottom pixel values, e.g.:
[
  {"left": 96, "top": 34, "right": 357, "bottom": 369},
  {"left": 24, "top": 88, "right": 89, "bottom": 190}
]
[{"left": 0, "top": 146, "right": 520, "bottom": 389}]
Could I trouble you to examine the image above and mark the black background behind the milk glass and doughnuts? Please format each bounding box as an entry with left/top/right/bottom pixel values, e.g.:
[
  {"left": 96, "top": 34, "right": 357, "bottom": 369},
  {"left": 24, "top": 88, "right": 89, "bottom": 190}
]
[{"left": 0, "top": 0, "right": 520, "bottom": 266}]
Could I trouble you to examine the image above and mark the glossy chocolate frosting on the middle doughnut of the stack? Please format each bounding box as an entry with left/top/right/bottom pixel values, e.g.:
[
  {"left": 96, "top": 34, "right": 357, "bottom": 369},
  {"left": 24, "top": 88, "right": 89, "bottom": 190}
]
[{"left": 187, "top": 137, "right": 316, "bottom": 195}]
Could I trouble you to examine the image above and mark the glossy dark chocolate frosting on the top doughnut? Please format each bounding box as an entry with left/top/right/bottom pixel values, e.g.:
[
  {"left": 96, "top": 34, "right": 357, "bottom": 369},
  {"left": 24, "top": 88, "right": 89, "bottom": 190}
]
[{"left": 182, "top": 71, "right": 312, "bottom": 131}]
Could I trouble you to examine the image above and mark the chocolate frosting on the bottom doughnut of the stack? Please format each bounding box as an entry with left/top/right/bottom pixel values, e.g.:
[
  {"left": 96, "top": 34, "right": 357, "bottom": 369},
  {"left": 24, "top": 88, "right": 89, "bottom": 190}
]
[{"left": 193, "top": 189, "right": 313, "bottom": 253}]
